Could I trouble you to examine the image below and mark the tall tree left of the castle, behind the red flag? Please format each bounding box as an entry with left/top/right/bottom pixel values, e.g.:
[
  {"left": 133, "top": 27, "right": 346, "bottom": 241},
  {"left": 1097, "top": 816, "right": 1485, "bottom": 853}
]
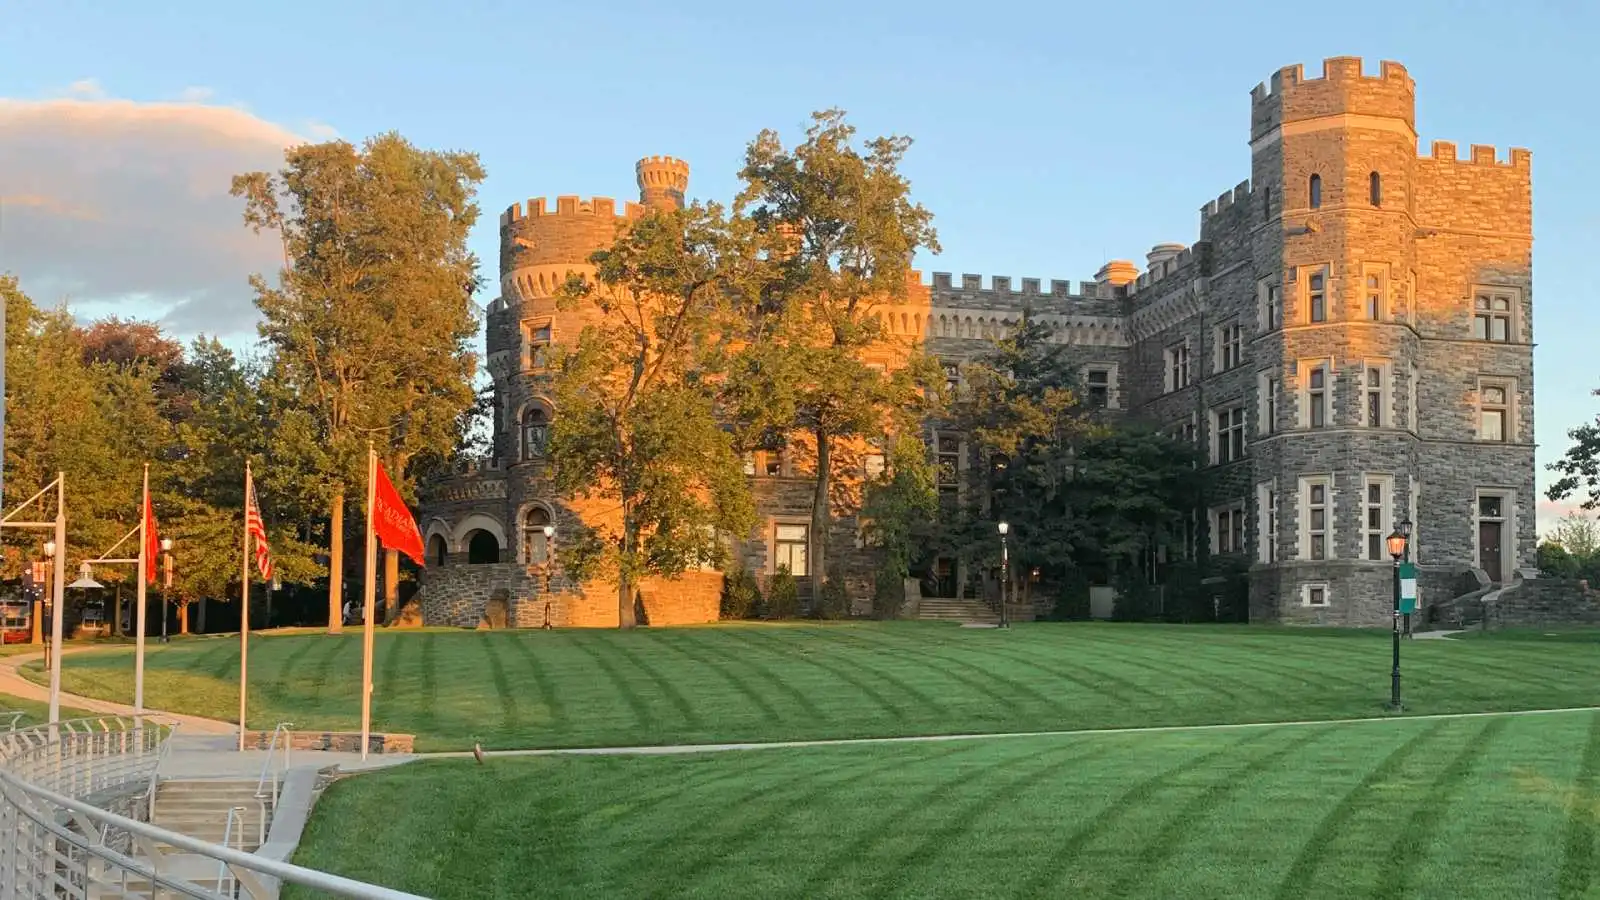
[{"left": 232, "top": 133, "right": 483, "bottom": 633}]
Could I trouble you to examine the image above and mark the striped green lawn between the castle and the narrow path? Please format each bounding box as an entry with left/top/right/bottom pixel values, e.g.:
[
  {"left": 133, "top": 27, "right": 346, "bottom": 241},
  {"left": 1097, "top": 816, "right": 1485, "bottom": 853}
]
[{"left": 30, "top": 623, "right": 1600, "bottom": 749}]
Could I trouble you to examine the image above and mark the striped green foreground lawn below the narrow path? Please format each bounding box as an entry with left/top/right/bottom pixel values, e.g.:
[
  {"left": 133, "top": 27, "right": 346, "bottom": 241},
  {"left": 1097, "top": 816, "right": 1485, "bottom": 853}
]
[{"left": 288, "top": 707, "right": 1600, "bottom": 900}]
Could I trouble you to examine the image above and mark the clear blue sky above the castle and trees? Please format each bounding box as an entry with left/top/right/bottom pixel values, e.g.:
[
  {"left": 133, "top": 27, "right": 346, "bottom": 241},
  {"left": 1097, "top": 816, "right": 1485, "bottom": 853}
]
[{"left": 0, "top": 0, "right": 1600, "bottom": 525}]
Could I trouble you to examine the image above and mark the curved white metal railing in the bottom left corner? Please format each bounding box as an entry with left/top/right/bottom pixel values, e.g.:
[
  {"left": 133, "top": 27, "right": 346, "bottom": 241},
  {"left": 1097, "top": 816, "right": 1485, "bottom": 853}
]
[{"left": 0, "top": 716, "right": 422, "bottom": 900}]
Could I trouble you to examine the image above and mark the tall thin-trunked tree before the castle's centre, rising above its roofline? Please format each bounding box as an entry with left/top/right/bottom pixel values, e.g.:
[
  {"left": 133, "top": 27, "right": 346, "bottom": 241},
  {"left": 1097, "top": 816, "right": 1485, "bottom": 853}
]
[{"left": 736, "top": 109, "right": 939, "bottom": 602}]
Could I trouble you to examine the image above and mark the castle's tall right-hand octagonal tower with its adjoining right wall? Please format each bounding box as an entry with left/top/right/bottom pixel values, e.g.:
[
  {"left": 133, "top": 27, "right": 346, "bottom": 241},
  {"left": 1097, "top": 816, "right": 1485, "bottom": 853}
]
[{"left": 1248, "top": 58, "right": 1534, "bottom": 614}]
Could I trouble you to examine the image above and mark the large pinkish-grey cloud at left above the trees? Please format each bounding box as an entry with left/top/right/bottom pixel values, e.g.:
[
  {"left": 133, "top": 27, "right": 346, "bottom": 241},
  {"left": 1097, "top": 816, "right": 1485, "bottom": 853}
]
[{"left": 0, "top": 80, "right": 306, "bottom": 335}]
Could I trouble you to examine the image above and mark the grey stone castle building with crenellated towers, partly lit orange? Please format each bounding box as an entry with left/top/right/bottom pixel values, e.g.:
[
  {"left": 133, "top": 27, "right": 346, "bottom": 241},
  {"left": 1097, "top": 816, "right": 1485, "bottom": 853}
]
[{"left": 422, "top": 58, "right": 1536, "bottom": 625}]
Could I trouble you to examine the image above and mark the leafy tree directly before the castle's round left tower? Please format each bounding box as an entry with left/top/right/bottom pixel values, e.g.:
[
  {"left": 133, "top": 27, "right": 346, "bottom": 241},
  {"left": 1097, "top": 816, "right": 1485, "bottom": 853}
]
[{"left": 550, "top": 205, "right": 754, "bottom": 628}]
